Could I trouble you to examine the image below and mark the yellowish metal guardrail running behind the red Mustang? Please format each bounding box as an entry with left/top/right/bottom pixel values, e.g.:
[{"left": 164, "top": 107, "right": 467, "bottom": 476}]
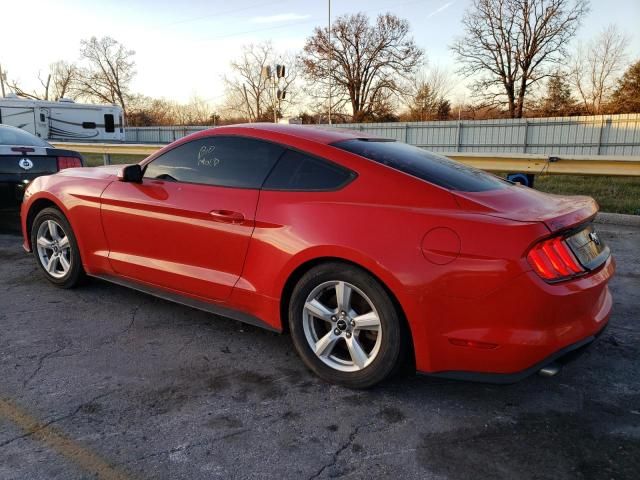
[{"left": 54, "top": 143, "right": 640, "bottom": 176}]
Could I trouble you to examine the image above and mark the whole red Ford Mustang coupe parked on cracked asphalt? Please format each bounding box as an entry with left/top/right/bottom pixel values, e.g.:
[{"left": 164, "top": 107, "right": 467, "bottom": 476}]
[{"left": 22, "top": 124, "right": 614, "bottom": 388}]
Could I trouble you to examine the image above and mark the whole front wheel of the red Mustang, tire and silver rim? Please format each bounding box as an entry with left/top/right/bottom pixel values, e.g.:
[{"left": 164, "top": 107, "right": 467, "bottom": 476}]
[{"left": 31, "top": 208, "right": 84, "bottom": 288}]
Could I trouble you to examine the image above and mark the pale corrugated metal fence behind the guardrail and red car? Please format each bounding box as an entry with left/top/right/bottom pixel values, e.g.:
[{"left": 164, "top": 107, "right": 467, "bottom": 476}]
[{"left": 126, "top": 113, "right": 640, "bottom": 156}]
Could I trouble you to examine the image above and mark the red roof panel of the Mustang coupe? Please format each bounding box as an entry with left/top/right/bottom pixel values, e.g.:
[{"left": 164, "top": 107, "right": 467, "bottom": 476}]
[{"left": 205, "top": 123, "right": 388, "bottom": 144}]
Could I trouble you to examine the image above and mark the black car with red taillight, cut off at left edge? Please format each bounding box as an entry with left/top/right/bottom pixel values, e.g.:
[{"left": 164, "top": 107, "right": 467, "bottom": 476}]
[{"left": 0, "top": 124, "right": 84, "bottom": 211}]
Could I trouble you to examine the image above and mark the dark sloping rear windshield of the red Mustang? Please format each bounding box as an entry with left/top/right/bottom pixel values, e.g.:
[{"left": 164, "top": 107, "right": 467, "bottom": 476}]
[{"left": 333, "top": 139, "right": 509, "bottom": 192}]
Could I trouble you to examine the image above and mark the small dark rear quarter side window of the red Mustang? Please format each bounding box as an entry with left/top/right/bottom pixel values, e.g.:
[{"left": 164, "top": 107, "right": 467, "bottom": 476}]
[{"left": 263, "top": 150, "right": 355, "bottom": 191}]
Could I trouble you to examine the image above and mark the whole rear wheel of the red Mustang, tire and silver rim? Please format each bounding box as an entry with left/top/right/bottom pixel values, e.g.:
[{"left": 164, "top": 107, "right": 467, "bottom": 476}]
[{"left": 289, "top": 262, "right": 404, "bottom": 388}]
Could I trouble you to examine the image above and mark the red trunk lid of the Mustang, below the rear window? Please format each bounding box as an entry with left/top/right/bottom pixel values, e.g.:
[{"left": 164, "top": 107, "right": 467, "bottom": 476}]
[{"left": 452, "top": 185, "right": 598, "bottom": 232}]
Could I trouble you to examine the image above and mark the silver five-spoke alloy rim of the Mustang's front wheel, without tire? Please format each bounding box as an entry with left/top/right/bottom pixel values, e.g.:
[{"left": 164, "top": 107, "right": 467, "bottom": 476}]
[{"left": 36, "top": 220, "right": 71, "bottom": 278}]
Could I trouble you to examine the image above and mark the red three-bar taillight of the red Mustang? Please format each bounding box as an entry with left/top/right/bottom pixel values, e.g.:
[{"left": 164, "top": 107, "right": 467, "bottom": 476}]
[{"left": 527, "top": 237, "right": 585, "bottom": 281}]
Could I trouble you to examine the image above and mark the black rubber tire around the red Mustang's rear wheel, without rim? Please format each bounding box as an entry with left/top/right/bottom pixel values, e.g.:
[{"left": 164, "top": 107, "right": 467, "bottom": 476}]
[{"left": 289, "top": 262, "right": 408, "bottom": 389}]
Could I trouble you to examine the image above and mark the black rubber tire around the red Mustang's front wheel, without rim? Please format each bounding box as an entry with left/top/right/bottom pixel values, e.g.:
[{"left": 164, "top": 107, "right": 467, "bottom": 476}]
[{"left": 31, "top": 207, "right": 85, "bottom": 288}]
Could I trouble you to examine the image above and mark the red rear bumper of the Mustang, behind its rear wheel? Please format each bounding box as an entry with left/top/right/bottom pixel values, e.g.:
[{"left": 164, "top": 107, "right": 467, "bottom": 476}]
[{"left": 414, "top": 257, "right": 615, "bottom": 383}]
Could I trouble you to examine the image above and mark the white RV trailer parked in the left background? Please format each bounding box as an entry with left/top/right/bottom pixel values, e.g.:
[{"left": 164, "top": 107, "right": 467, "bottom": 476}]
[{"left": 0, "top": 94, "right": 125, "bottom": 142}]
